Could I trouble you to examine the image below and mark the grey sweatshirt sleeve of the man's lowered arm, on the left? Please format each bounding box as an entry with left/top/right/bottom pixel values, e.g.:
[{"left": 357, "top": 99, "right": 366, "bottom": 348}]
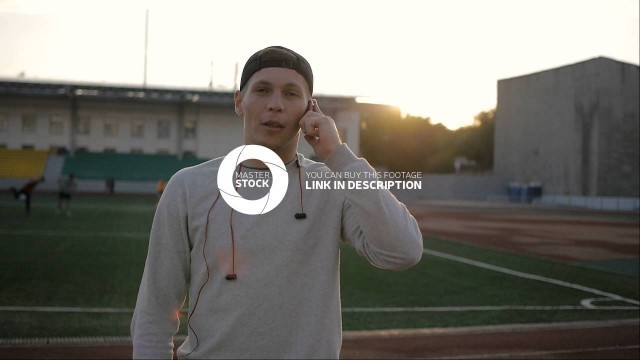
[{"left": 131, "top": 173, "right": 190, "bottom": 359}]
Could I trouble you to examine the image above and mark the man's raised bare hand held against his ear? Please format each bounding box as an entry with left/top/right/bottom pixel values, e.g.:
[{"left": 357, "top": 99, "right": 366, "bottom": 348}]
[{"left": 299, "top": 99, "right": 342, "bottom": 161}]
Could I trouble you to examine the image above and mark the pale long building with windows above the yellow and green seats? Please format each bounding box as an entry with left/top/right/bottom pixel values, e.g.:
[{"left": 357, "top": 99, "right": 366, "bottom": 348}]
[{"left": 0, "top": 81, "right": 360, "bottom": 158}]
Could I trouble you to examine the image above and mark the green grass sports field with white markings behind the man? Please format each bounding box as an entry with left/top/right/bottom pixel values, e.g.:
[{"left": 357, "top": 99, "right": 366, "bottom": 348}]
[{"left": 0, "top": 194, "right": 640, "bottom": 338}]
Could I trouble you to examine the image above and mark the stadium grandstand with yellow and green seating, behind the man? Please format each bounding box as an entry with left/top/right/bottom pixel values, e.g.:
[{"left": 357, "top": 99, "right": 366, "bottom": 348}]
[{"left": 0, "top": 80, "right": 360, "bottom": 193}]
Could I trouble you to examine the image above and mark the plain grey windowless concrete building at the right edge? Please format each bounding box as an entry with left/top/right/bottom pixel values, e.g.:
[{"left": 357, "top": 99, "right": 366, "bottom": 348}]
[{"left": 494, "top": 57, "right": 640, "bottom": 197}]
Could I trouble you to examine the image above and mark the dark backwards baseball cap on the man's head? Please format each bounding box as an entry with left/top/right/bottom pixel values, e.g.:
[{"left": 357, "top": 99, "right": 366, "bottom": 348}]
[{"left": 240, "top": 46, "right": 313, "bottom": 94}]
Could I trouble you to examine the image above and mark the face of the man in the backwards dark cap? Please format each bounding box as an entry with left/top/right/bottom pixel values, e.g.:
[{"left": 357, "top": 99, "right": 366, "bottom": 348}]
[{"left": 235, "top": 67, "right": 311, "bottom": 161}]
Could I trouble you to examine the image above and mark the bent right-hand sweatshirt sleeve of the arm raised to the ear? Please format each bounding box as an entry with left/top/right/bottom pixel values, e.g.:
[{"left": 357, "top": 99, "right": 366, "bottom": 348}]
[{"left": 325, "top": 144, "right": 423, "bottom": 270}]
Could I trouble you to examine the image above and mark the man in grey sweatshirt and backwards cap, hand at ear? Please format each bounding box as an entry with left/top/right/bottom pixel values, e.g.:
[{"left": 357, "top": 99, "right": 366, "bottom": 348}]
[{"left": 131, "top": 47, "right": 423, "bottom": 359}]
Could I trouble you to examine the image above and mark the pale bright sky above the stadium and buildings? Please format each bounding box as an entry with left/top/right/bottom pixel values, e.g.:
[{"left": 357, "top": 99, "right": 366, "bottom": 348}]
[{"left": 0, "top": 0, "right": 640, "bottom": 129}]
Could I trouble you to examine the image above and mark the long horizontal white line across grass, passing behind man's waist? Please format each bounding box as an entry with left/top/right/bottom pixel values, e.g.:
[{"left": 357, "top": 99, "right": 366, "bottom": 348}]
[{"left": 0, "top": 305, "right": 638, "bottom": 314}]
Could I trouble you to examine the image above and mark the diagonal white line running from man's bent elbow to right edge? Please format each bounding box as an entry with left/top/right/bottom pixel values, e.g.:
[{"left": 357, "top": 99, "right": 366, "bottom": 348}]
[{"left": 424, "top": 249, "right": 640, "bottom": 305}]
